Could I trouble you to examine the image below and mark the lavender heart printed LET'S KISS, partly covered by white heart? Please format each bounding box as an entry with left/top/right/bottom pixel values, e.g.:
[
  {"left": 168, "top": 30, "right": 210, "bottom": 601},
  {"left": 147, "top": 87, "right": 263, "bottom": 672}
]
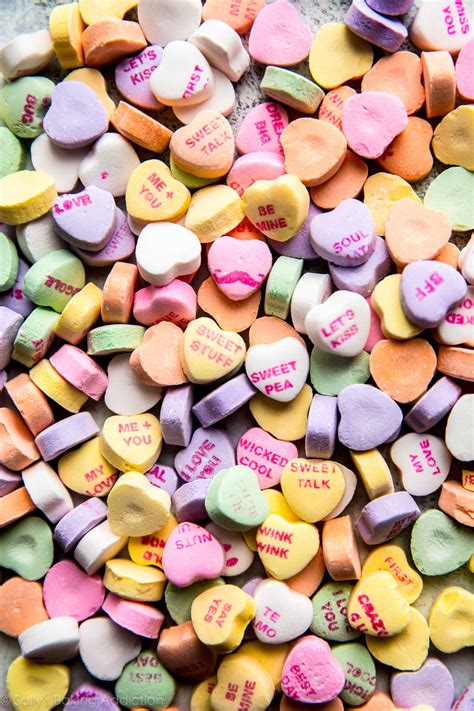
[{"left": 115, "top": 44, "right": 163, "bottom": 111}]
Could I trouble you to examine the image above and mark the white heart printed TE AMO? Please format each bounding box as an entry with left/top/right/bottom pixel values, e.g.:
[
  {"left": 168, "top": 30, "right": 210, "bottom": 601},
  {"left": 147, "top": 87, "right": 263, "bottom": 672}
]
[{"left": 252, "top": 580, "right": 313, "bottom": 644}]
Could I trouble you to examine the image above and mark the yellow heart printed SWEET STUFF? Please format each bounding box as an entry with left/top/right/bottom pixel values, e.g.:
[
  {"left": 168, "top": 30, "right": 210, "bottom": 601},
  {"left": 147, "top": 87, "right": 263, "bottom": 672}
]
[{"left": 181, "top": 316, "right": 246, "bottom": 385}]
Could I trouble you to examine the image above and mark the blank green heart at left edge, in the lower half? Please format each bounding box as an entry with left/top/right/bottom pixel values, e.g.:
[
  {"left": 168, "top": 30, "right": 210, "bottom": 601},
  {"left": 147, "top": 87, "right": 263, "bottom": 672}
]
[{"left": 0, "top": 516, "right": 53, "bottom": 580}]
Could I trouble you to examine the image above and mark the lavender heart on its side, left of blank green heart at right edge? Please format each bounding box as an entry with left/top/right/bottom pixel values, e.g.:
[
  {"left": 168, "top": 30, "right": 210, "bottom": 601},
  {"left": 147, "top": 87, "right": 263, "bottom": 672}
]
[{"left": 355, "top": 491, "right": 421, "bottom": 546}]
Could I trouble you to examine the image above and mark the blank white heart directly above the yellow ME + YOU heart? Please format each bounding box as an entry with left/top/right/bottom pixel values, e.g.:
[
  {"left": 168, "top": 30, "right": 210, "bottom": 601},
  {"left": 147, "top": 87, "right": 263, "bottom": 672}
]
[{"left": 105, "top": 353, "right": 162, "bottom": 415}]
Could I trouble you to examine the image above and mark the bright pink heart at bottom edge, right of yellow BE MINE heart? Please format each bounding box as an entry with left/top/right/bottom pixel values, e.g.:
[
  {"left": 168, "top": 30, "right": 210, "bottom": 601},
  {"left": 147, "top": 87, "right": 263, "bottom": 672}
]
[{"left": 281, "top": 635, "right": 345, "bottom": 705}]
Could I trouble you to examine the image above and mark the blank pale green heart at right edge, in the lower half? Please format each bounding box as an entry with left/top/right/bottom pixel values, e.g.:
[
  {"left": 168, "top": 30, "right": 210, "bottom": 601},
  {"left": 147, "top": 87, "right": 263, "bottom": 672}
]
[{"left": 410, "top": 509, "right": 474, "bottom": 575}]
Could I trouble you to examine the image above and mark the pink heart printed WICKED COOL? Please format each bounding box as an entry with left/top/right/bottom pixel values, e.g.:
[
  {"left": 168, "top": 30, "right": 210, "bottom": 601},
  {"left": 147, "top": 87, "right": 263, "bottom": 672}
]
[{"left": 237, "top": 427, "right": 298, "bottom": 489}]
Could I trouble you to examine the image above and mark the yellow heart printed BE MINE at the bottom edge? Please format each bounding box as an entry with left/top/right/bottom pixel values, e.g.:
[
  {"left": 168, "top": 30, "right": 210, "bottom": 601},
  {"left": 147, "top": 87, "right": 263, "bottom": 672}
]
[{"left": 211, "top": 652, "right": 275, "bottom": 711}]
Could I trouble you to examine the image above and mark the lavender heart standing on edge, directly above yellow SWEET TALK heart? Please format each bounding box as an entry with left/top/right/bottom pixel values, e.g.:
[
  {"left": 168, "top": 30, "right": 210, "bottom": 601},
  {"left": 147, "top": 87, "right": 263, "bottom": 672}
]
[{"left": 304, "top": 393, "right": 337, "bottom": 459}]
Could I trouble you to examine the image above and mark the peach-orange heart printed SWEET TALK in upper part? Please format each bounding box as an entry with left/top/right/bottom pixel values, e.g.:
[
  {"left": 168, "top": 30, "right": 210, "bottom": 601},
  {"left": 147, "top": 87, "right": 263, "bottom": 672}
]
[{"left": 170, "top": 110, "right": 235, "bottom": 178}]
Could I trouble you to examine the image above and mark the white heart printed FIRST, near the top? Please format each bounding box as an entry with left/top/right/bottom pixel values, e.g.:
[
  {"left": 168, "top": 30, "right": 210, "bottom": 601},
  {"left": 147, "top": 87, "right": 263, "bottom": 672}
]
[{"left": 150, "top": 40, "right": 214, "bottom": 106}]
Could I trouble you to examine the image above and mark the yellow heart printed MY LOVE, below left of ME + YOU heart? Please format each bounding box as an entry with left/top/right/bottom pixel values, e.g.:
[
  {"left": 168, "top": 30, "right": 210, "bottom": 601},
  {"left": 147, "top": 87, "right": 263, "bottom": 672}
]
[{"left": 58, "top": 437, "right": 117, "bottom": 496}]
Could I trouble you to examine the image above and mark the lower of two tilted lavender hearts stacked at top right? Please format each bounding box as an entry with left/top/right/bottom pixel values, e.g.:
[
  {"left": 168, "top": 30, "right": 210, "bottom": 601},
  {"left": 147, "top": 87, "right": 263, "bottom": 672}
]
[{"left": 344, "top": 0, "right": 408, "bottom": 52}]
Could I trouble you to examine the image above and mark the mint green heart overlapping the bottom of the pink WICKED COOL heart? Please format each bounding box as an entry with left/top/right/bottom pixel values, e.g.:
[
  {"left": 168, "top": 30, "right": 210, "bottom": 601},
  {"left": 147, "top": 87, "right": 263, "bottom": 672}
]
[{"left": 206, "top": 465, "right": 268, "bottom": 531}]
